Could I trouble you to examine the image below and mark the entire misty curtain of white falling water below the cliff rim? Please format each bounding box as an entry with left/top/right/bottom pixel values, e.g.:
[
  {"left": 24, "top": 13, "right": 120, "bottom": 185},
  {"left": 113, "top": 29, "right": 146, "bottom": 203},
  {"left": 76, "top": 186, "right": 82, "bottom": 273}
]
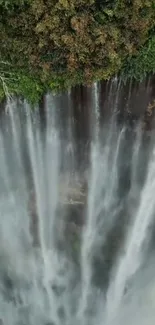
[{"left": 0, "top": 83, "right": 155, "bottom": 325}]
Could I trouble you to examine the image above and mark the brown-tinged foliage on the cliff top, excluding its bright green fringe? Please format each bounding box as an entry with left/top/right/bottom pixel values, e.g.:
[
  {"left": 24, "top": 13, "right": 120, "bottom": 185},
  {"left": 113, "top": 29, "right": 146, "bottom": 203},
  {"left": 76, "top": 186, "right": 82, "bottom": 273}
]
[{"left": 0, "top": 0, "right": 155, "bottom": 88}]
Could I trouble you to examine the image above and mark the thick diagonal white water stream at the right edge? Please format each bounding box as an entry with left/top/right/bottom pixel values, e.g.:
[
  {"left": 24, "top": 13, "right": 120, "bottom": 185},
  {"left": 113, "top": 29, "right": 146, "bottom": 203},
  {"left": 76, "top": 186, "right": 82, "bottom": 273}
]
[{"left": 107, "top": 151, "right": 155, "bottom": 324}]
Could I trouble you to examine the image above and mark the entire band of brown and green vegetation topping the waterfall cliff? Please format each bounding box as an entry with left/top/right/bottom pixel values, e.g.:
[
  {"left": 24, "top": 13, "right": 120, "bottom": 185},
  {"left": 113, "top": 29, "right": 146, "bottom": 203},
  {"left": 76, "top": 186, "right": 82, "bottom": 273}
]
[{"left": 0, "top": 0, "right": 155, "bottom": 102}]
